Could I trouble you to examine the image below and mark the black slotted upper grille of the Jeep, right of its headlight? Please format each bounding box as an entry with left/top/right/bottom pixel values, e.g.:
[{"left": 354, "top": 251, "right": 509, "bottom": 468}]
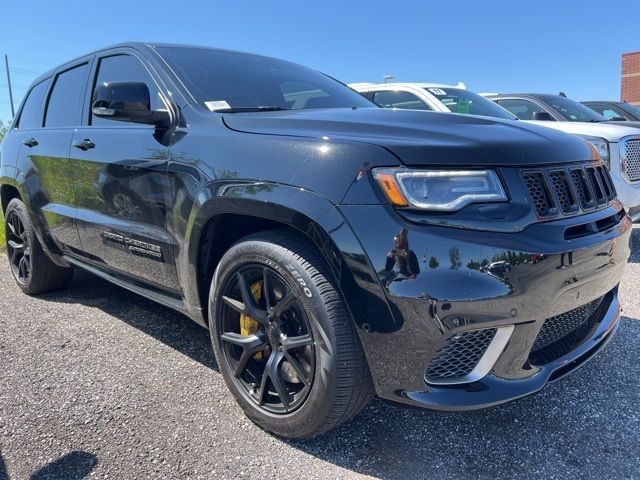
[{"left": 522, "top": 165, "right": 616, "bottom": 217}]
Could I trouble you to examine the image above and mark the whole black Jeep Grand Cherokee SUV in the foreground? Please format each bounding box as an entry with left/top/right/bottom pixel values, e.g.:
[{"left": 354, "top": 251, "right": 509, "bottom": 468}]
[{"left": 0, "top": 43, "right": 631, "bottom": 438}]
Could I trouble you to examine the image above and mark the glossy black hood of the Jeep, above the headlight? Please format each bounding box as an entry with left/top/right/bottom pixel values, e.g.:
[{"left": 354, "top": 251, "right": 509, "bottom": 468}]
[{"left": 224, "top": 108, "right": 592, "bottom": 166}]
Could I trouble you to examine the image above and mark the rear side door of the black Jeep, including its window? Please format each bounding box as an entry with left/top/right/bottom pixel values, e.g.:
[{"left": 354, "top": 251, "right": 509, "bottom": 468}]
[{"left": 17, "top": 58, "right": 91, "bottom": 252}]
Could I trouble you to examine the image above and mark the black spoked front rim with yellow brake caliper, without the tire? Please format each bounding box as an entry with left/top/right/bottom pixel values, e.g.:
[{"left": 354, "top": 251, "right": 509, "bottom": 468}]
[{"left": 216, "top": 263, "right": 316, "bottom": 414}]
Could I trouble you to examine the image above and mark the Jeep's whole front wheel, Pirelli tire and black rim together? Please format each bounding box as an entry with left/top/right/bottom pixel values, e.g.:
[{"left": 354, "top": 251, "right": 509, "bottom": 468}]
[{"left": 209, "top": 231, "right": 373, "bottom": 438}]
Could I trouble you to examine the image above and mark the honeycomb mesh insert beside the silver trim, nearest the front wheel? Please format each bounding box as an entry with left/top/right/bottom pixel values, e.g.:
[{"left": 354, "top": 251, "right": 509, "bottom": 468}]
[{"left": 427, "top": 328, "right": 497, "bottom": 381}]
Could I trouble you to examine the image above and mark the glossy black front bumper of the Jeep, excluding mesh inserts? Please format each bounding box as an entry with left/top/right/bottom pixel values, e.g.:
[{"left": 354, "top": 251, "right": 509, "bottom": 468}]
[{"left": 340, "top": 204, "right": 631, "bottom": 410}]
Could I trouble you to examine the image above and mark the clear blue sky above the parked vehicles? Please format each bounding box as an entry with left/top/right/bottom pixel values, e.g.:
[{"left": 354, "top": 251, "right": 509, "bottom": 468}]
[{"left": 0, "top": 0, "right": 640, "bottom": 122}]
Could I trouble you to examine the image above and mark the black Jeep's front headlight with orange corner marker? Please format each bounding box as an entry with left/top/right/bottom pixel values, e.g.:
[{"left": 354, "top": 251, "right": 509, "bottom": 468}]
[{"left": 373, "top": 168, "right": 507, "bottom": 212}]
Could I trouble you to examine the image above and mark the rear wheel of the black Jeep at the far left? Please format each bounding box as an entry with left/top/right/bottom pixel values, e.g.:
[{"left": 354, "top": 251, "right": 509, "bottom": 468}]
[{"left": 4, "top": 198, "right": 73, "bottom": 295}]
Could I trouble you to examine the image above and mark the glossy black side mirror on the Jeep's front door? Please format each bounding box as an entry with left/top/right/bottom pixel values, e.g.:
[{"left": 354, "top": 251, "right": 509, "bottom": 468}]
[{"left": 91, "top": 82, "right": 169, "bottom": 126}]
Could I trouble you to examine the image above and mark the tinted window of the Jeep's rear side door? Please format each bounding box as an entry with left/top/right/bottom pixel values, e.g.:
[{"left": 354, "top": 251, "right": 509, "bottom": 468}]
[{"left": 44, "top": 63, "right": 87, "bottom": 127}]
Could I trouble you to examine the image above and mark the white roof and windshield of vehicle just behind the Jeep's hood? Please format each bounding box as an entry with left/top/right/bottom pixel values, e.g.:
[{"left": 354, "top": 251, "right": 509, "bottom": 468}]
[{"left": 349, "top": 83, "right": 516, "bottom": 120}]
